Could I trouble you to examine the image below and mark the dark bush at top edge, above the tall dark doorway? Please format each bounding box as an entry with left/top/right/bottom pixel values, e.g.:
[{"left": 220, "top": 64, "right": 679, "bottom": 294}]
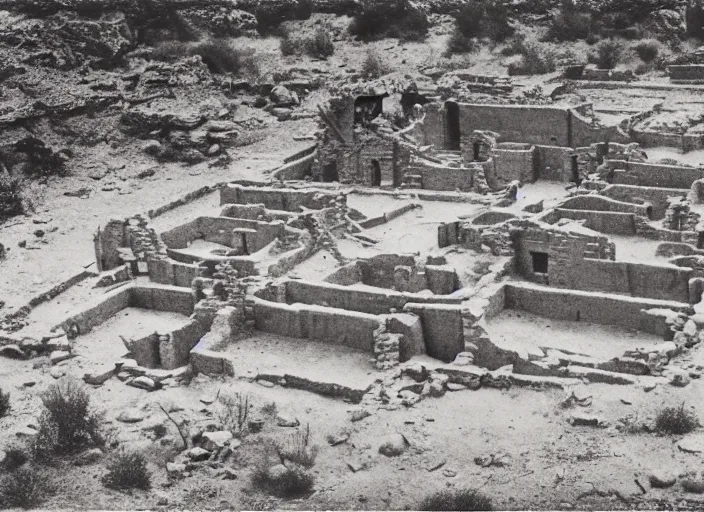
[{"left": 455, "top": 0, "right": 515, "bottom": 41}]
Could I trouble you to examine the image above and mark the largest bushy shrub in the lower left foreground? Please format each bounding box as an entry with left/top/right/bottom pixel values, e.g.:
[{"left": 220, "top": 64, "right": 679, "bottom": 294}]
[{"left": 34, "top": 377, "right": 105, "bottom": 455}]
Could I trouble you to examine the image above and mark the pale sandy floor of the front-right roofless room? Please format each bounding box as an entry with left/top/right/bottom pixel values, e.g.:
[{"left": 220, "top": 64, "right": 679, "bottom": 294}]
[{"left": 487, "top": 309, "right": 662, "bottom": 360}]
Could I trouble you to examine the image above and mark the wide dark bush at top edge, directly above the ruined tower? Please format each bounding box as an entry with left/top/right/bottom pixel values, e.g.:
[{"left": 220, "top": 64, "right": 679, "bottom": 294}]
[{"left": 349, "top": 0, "right": 430, "bottom": 40}]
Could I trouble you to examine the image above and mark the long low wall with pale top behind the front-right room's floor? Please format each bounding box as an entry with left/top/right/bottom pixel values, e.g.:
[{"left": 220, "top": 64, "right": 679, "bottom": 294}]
[{"left": 504, "top": 283, "right": 689, "bottom": 334}]
